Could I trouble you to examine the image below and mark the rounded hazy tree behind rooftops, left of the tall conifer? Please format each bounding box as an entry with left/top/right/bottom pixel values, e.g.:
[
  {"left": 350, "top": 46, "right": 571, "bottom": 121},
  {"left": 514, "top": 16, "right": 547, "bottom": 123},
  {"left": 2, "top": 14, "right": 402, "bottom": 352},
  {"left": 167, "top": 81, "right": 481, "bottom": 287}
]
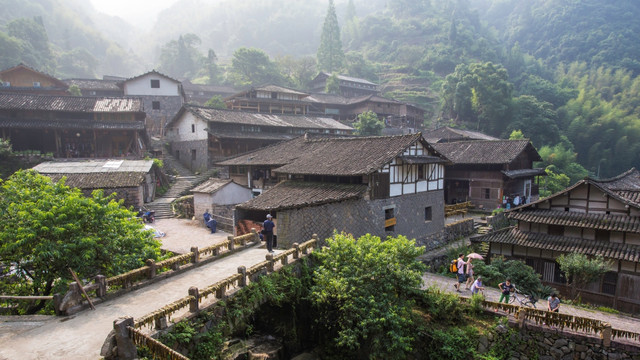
[{"left": 229, "top": 47, "right": 283, "bottom": 86}]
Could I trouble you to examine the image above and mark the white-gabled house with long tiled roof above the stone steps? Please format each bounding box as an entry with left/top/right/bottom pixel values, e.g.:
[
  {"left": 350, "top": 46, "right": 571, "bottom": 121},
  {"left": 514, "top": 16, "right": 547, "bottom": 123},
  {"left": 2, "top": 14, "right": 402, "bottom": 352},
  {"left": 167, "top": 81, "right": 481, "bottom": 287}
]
[{"left": 166, "top": 105, "right": 353, "bottom": 173}]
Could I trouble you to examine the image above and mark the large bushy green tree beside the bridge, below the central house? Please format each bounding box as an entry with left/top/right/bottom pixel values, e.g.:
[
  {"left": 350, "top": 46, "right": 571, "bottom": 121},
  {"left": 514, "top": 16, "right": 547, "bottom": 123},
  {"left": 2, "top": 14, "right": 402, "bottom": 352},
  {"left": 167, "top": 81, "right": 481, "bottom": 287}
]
[{"left": 310, "top": 233, "right": 425, "bottom": 359}]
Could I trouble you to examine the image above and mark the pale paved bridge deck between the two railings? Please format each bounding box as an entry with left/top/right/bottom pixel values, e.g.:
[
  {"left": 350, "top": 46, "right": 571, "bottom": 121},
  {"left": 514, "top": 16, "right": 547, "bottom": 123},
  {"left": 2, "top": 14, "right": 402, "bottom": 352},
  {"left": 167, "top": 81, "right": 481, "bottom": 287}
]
[{"left": 0, "top": 245, "right": 278, "bottom": 360}]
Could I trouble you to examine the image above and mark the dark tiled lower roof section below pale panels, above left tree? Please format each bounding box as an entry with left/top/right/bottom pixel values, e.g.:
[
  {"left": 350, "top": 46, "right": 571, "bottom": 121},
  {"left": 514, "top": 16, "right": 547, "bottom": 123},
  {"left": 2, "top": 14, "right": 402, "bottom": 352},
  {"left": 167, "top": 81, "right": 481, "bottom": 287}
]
[{"left": 41, "top": 172, "right": 144, "bottom": 189}]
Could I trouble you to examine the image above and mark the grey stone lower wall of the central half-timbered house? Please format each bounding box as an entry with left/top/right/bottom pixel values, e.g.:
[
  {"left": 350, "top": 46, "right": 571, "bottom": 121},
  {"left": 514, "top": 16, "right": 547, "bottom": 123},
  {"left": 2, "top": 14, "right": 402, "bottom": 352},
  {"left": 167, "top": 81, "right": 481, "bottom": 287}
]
[{"left": 268, "top": 191, "right": 444, "bottom": 247}]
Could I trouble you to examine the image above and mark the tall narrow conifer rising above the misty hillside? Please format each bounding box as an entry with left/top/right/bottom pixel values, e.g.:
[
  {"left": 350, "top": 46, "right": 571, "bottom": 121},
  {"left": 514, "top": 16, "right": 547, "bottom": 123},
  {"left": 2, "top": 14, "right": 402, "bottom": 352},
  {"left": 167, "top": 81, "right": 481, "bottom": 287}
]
[{"left": 317, "top": 0, "right": 344, "bottom": 73}]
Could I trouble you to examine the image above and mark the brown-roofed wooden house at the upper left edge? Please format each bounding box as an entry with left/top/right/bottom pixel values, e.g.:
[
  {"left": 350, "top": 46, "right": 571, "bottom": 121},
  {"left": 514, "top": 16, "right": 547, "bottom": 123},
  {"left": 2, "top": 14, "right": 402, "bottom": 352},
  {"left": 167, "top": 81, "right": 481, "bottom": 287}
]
[{"left": 0, "top": 64, "right": 69, "bottom": 95}]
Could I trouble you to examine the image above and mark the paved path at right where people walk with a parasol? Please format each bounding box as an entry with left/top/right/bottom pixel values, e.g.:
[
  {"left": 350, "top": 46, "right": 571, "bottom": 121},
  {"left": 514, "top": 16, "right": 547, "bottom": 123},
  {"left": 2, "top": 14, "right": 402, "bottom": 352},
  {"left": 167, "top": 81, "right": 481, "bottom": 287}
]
[{"left": 423, "top": 273, "right": 640, "bottom": 332}]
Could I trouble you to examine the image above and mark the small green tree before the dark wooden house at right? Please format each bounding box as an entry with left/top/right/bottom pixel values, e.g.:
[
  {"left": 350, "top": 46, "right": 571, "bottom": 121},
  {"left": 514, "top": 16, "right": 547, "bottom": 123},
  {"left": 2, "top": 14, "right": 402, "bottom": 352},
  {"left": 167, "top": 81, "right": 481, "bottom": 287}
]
[{"left": 556, "top": 253, "right": 611, "bottom": 299}]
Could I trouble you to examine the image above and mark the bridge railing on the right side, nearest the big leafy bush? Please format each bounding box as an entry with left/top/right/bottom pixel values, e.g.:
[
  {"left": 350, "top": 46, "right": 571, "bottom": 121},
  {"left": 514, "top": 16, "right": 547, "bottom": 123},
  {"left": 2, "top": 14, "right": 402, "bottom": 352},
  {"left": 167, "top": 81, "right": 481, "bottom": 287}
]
[{"left": 105, "top": 235, "right": 318, "bottom": 360}]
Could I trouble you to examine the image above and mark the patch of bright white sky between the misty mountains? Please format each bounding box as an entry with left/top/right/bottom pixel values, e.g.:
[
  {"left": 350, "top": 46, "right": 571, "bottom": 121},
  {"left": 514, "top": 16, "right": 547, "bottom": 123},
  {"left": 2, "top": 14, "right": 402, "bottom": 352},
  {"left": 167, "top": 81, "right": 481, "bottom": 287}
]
[{"left": 91, "top": 0, "right": 178, "bottom": 24}]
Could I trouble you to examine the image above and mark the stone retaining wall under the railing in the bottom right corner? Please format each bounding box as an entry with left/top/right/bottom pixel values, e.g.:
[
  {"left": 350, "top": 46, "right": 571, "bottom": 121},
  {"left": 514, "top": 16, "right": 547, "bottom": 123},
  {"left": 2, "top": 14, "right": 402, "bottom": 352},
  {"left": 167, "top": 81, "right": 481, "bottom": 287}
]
[{"left": 478, "top": 323, "right": 640, "bottom": 360}]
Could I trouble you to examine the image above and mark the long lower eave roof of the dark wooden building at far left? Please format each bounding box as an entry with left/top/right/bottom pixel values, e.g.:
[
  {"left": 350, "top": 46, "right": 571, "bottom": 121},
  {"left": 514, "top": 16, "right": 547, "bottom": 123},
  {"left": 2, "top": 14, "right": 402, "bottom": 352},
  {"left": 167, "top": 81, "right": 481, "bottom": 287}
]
[{"left": 0, "top": 117, "right": 144, "bottom": 130}]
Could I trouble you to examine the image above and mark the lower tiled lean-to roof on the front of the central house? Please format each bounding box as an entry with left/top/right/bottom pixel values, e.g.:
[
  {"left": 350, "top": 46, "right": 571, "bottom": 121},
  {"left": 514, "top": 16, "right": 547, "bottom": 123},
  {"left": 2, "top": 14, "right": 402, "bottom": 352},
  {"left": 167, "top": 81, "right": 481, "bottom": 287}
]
[{"left": 237, "top": 181, "right": 367, "bottom": 211}]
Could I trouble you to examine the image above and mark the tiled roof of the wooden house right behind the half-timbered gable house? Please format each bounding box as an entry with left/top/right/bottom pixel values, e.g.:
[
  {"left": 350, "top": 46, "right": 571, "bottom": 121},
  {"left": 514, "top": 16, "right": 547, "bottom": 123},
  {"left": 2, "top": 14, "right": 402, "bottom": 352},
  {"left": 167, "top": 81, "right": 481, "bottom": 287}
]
[{"left": 431, "top": 140, "right": 542, "bottom": 165}]
